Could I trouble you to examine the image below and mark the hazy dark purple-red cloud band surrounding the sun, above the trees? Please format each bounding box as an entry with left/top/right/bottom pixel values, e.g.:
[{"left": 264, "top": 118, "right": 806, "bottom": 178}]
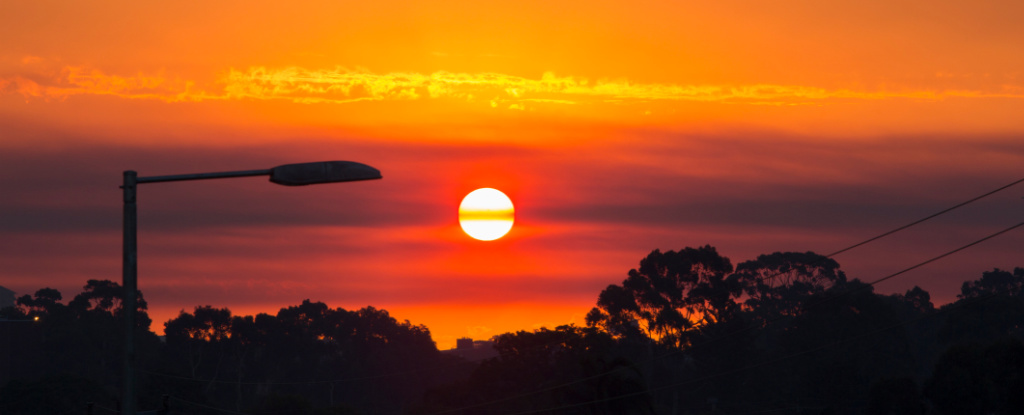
[{"left": 0, "top": 127, "right": 1024, "bottom": 336}]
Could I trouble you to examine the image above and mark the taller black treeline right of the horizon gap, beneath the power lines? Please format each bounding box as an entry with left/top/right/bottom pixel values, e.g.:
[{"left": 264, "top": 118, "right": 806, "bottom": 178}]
[{"left": 421, "top": 246, "right": 1024, "bottom": 415}]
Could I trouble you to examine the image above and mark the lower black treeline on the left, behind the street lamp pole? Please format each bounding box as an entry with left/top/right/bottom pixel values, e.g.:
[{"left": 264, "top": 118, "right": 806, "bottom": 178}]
[{"left": 0, "top": 281, "right": 472, "bottom": 415}]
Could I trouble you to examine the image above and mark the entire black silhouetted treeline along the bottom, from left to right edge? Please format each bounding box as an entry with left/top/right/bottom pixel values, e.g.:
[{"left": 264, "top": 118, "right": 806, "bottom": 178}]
[{"left": 0, "top": 246, "right": 1024, "bottom": 415}]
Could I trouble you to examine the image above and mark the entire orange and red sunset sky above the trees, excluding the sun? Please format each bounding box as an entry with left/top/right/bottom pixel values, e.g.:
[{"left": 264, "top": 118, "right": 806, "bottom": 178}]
[{"left": 0, "top": 0, "right": 1024, "bottom": 348}]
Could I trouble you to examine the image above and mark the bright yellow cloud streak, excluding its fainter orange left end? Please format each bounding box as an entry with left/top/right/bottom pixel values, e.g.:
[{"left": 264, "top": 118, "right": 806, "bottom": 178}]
[{"left": 216, "top": 67, "right": 1024, "bottom": 105}]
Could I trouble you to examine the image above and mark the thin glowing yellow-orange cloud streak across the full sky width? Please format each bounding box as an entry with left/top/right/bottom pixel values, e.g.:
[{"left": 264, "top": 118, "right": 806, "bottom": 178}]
[{"left": 8, "top": 56, "right": 1024, "bottom": 106}]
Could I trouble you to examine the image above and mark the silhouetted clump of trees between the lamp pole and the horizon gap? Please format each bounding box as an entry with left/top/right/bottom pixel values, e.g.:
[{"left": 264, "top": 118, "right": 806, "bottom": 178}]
[{"left": 158, "top": 300, "right": 444, "bottom": 413}]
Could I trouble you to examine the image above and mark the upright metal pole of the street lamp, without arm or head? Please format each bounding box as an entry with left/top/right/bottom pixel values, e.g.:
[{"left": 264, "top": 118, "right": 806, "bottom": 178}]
[{"left": 121, "top": 170, "right": 138, "bottom": 415}]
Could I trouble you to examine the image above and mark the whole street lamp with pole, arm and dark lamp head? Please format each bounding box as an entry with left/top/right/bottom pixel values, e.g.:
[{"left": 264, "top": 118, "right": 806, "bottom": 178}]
[{"left": 121, "top": 161, "right": 381, "bottom": 415}]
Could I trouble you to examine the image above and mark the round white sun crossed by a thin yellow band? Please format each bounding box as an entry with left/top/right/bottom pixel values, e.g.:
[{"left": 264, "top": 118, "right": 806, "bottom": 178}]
[{"left": 459, "top": 188, "right": 515, "bottom": 241}]
